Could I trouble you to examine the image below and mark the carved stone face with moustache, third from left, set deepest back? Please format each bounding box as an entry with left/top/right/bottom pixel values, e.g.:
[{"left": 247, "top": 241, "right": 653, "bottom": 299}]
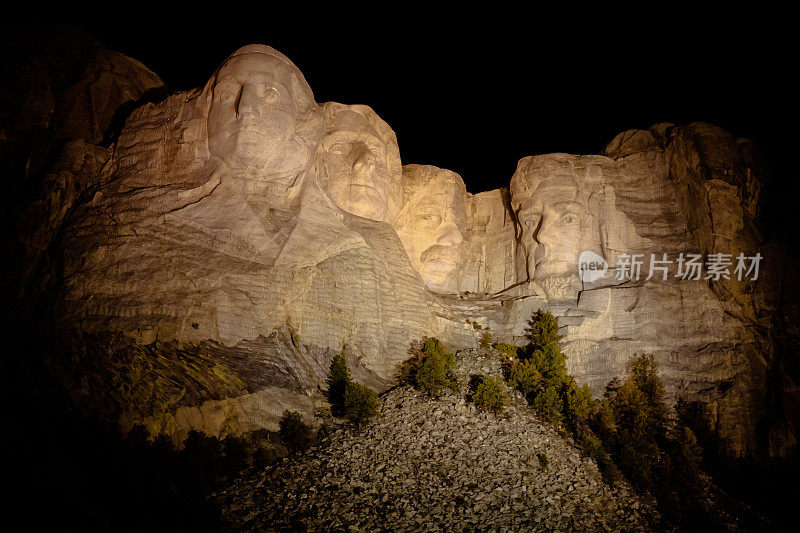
[{"left": 396, "top": 165, "right": 466, "bottom": 293}]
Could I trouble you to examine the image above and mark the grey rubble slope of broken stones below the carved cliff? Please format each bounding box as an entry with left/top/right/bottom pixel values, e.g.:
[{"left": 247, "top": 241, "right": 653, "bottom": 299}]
[{"left": 214, "top": 351, "right": 657, "bottom": 531}]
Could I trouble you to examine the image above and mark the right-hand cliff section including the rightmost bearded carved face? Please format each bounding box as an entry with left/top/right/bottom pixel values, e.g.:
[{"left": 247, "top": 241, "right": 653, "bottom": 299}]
[{"left": 450, "top": 123, "right": 798, "bottom": 454}]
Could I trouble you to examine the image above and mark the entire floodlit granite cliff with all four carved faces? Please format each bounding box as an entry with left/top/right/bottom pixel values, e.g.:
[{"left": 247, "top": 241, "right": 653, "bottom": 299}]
[{"left": 9, "top": 37, "right": 800, "bottom": 454}]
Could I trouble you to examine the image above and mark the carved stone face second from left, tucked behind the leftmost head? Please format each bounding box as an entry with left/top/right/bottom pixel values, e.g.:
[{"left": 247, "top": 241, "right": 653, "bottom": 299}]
[{"left": 317, "top": 102, "right": 402, "bottom": 221}]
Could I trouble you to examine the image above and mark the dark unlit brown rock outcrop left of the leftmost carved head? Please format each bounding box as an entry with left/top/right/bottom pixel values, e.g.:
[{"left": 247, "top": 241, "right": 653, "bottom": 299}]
[{"left": 0, "top": 28, "right": 165, "bottom": 312}]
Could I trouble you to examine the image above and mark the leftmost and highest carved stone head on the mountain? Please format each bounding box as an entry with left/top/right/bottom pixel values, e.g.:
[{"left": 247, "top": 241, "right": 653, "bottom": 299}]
[{"left": 208, "top": 47, "right": 313, "bottom": 181}]
